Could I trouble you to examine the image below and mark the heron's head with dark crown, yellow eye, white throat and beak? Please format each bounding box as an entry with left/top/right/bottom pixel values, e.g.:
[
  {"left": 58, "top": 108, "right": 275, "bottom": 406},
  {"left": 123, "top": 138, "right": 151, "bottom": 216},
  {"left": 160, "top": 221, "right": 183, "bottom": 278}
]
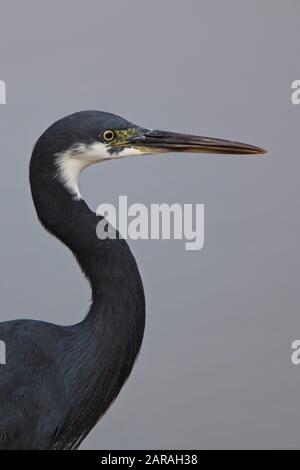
[{"left": 31, "top": 111, "right": 265, "bottom": 198}]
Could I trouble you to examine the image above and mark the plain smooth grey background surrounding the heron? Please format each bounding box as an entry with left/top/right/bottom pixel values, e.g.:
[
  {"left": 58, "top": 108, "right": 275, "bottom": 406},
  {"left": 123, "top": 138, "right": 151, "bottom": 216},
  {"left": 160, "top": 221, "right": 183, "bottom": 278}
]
[{"left": 0, "top": 0, "right": 300, "bottom": 449}]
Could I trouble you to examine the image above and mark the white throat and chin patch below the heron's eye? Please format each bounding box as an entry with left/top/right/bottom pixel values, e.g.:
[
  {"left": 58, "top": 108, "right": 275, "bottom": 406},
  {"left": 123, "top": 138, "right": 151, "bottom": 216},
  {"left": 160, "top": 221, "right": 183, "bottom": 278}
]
[{"left": 55, "top": 142, "right": 142, "bottom": 200}]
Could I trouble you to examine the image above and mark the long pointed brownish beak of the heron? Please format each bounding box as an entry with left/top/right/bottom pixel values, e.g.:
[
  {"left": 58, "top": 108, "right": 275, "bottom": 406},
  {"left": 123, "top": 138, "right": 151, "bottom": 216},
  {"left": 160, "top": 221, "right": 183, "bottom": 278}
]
[{"left": 131, "top": 129, "right": 266, "bottom": 155}]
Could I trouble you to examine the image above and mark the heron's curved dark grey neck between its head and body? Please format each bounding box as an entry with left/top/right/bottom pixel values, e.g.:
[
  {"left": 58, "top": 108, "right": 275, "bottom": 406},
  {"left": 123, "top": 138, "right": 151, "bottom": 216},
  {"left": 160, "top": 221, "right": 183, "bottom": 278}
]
[{"left": 30, "top": 147, "right": 145, "bottom": 360}]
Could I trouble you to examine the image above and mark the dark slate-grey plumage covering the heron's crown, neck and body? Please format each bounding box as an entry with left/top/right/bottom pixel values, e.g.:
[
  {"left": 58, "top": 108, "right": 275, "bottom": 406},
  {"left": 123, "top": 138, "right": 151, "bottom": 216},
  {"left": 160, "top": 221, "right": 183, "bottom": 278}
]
[{"left": 0, "top": 112, "right": 145, "bottom": 449}]
